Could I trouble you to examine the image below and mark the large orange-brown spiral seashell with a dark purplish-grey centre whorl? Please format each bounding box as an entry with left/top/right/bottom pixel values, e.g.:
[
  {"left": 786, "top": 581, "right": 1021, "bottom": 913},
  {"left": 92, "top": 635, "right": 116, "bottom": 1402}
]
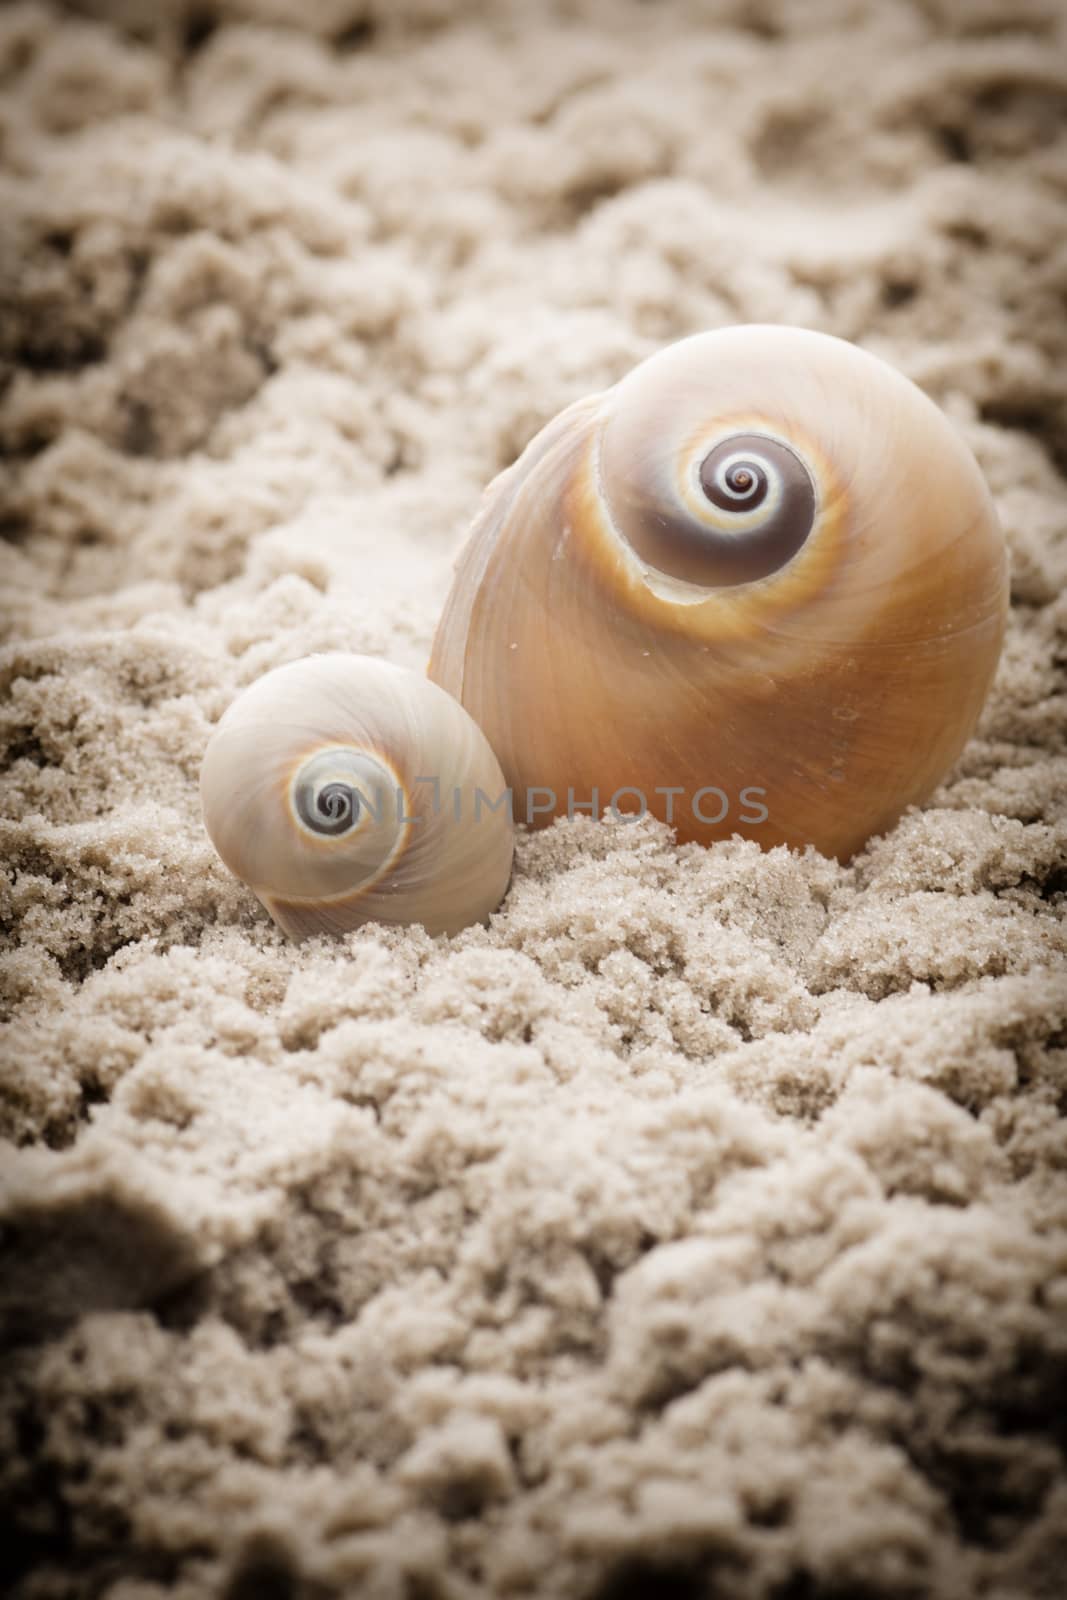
[{"left": 430, "top": 326, "right": 1008, "bottom": 859}]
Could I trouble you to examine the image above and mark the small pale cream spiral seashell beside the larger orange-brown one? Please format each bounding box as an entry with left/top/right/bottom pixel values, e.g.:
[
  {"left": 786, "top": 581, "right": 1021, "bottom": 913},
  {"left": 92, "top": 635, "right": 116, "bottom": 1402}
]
[{"left": 200, "top": 654, "right": 514, "bottom": 938}]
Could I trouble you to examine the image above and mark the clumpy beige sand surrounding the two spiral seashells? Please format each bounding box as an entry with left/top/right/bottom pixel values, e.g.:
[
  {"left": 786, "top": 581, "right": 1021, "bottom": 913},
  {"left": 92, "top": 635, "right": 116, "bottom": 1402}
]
[{"left": 0, "top": 0, "right": 1067, "bottom": 1600}]
